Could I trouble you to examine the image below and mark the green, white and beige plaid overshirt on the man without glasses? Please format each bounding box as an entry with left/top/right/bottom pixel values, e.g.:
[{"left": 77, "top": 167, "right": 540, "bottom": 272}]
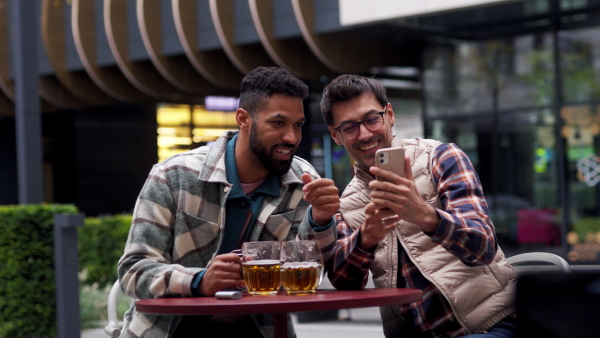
[{"left": 118, "top": 131, "right": 336, "bottom": 338}]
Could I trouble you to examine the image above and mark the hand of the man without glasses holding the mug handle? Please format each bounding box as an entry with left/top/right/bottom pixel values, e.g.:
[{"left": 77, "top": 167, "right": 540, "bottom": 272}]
[{"left": 200, "top": 253, "right": 243, "bottom": 296}]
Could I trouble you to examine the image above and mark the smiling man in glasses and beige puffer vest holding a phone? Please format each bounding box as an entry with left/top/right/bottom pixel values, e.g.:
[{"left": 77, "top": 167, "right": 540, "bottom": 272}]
[{"left": 321, "top": 75, "right": 516, "bottom": 337}]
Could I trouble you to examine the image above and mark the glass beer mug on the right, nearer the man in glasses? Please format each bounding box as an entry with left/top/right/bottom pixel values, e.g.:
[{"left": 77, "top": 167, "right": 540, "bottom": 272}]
[{"left": 281, "top": 240, "right": 323, "bottom": 295}]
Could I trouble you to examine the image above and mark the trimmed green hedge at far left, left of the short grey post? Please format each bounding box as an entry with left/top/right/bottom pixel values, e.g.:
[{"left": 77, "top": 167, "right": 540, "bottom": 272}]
[{"left": 0, "top": 204, "right": 78, "bottom": 338}]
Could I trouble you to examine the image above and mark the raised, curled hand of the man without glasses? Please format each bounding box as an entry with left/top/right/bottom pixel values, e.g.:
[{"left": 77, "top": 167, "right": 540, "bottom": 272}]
[{"left": 302, "top": 173, "right": 340, "bottom": 226}]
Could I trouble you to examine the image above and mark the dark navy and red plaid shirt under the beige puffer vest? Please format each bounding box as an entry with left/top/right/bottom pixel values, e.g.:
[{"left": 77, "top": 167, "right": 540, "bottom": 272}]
[{"left": 327, "top": 144, "right": 497, "bottom": 337}]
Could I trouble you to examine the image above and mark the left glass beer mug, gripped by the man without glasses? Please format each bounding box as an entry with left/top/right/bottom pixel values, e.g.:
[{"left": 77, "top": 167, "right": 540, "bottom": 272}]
[{"left": 242, "top": 242, "right": 281, "bottom": 295}]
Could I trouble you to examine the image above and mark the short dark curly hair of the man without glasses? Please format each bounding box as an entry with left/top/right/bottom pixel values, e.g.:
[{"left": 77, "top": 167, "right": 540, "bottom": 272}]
[{"left": 240, "top": 67, "right": 308, "bottom": 116}]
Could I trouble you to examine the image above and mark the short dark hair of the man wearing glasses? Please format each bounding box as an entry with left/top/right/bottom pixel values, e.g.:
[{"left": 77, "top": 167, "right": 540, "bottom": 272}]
[{"left": 321, "top": 74, "right": 388, "bottom": 125}]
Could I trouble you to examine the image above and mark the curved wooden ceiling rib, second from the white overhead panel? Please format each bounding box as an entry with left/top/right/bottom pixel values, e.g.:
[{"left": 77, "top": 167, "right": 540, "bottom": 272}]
[{"left": 248, "top": 0, "right": 333, "bottom": 79}]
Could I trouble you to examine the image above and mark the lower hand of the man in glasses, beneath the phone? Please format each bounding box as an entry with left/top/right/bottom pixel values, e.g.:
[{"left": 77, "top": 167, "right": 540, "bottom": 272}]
[{"left": 358, "top": 202, "right": 400, "bottom": 250}]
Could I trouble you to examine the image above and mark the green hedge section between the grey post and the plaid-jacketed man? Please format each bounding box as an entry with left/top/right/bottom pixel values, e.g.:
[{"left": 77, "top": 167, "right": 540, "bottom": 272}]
[{"left": 77, "top": 215, "right": 131, "bottom": 288}]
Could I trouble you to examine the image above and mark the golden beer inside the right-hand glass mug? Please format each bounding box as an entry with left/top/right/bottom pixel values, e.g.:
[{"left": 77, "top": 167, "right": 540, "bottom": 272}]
[{"left": 281, "top": 262, "right": 322, "bottom": 295}]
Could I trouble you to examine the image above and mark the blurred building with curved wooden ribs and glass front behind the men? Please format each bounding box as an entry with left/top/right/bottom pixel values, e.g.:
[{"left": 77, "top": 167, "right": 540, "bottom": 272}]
[{"left": 0, "top": 0, "right": 600, "bottom": 264}]
